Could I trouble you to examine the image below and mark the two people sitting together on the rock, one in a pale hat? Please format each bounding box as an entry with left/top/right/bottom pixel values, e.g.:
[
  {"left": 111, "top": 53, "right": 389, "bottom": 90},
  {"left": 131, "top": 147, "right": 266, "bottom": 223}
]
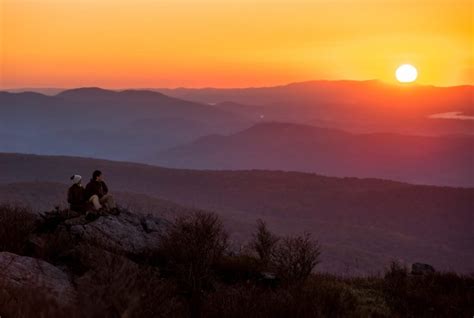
[{"left": 67, "top": 170, "right": 117, "bottom": 213}]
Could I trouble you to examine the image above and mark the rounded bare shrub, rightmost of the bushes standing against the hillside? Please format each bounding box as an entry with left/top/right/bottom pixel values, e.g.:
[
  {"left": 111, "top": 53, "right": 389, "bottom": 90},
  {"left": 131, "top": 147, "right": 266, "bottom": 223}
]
[{"left": 272, "top": 234, "right": 321, "bottom": 284}]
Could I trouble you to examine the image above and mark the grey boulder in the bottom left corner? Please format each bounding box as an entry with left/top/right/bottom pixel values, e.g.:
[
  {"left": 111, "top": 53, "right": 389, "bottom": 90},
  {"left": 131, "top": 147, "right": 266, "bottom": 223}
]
[{"left": 0, "top": 252, "right": 76, "bottom": 307}]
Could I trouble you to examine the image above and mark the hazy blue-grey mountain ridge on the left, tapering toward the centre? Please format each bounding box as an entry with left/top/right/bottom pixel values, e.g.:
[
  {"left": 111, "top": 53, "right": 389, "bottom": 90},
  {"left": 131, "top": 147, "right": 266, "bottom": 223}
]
[{"left": 0, "top": 88, "right": 250, "bottom": 160}]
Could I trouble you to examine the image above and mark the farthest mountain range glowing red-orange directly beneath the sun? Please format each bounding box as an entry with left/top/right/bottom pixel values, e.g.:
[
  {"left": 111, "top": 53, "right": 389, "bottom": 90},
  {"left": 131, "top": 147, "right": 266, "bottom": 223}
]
[{"left": 158, "top": 81, "right": 474, "bottom": 135}]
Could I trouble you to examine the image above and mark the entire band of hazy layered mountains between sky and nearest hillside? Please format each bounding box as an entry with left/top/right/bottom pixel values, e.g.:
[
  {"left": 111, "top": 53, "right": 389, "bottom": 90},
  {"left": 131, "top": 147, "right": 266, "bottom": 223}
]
[{"left": 0, "top": 81, "right": 474, "bottom": 186}]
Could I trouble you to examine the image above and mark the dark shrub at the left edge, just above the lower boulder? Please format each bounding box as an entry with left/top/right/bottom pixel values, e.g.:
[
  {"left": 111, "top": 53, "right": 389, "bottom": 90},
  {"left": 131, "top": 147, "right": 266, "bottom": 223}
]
[{"left": 0, "top": 205, "right": 36, "bottom": 254}]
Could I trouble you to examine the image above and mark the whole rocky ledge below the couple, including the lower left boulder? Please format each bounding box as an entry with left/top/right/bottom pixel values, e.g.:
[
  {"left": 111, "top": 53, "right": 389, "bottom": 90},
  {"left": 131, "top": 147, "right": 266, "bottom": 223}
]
[{"left": 0, "top": 211, "right": 169, "bottom": 310}]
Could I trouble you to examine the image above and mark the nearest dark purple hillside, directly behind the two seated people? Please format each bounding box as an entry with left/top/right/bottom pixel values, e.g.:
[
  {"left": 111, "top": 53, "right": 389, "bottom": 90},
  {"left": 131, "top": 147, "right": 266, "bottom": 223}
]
[{"left": 0, "top": 154, "right": 474, "bottom": 274}]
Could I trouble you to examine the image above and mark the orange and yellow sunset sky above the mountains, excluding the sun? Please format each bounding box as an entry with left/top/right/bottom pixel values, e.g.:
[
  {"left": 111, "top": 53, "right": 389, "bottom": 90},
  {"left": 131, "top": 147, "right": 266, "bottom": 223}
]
[{"left": 0, "top": 0, "right": 474, "bottom": 88}]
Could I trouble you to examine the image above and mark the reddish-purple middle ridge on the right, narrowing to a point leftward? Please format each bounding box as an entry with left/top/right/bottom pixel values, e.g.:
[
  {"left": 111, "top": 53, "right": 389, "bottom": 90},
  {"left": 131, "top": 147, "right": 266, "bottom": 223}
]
[{"left": 150, "top": 123, "right": 474, "bottom": 187}]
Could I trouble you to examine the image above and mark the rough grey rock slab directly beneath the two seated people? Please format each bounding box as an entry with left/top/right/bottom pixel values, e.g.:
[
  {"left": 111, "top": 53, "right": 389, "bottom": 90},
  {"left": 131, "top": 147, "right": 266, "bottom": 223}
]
[{"left": 66, "top": 211, "right": 168, "bottom": 255}]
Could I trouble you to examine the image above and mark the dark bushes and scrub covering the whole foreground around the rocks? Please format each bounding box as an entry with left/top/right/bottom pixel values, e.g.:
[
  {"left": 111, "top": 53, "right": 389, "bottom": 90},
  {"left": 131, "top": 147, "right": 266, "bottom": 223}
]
[{"left": 0, "top": 206, "right": 474, "bottom": 318}]
